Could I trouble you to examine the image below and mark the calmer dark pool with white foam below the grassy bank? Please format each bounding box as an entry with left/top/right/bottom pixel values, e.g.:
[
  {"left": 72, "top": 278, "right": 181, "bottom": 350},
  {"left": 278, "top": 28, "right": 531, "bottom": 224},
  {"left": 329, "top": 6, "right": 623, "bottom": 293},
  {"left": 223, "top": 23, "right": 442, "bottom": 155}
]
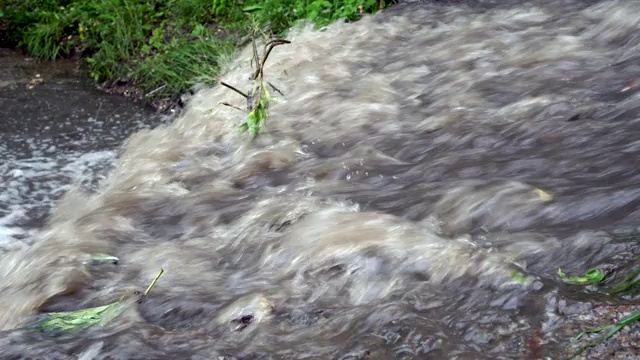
[{"left": 0, "top": 49, "right": 166, "bottom": 253}]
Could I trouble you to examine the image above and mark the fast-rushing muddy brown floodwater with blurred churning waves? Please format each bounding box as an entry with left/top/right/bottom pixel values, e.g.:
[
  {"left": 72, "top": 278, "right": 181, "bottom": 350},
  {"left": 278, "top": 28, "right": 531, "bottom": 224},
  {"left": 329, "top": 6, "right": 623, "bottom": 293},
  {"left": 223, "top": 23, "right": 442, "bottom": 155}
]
[{"left": 0, "top": 0, "right": 640, "bottom": 359}]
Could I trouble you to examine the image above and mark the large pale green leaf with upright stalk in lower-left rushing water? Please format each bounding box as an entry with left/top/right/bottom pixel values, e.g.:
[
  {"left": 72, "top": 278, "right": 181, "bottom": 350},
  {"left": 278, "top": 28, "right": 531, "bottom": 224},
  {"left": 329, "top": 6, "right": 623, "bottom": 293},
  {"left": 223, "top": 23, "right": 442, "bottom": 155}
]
[{"left": 37, "top": 269, "right": 164, "bottom": 335}]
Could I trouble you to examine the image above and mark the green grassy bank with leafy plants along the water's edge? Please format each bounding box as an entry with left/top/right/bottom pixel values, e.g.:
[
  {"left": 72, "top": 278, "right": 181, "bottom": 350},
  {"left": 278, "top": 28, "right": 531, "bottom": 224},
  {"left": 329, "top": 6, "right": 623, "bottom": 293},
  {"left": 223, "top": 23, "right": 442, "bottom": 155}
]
[{"left": 0, "top": 0, "right": 397, "bottom": 111}]
